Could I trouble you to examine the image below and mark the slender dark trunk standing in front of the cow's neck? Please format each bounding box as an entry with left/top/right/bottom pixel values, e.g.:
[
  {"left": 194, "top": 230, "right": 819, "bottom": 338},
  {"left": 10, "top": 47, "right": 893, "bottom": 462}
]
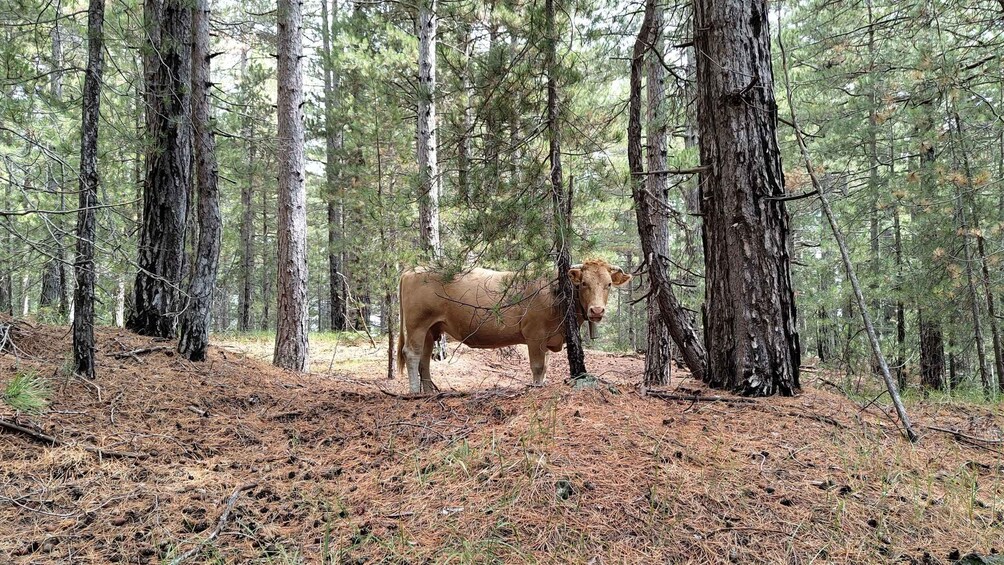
[{"left": 544, "top": 0, "right": 585, "bottom": 378}]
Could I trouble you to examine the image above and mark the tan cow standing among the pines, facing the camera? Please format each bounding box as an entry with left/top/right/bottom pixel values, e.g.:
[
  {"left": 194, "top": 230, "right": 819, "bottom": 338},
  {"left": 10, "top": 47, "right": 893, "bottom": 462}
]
[{"left": 398, "top": 260, "right": 632, "bottom": 392}]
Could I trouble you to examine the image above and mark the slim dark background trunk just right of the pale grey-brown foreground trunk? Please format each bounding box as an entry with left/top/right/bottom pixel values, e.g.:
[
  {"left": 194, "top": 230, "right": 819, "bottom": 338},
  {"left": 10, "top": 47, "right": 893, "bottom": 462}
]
[{"left": 320, "top": 0, "right": 346, "bottom": 331}]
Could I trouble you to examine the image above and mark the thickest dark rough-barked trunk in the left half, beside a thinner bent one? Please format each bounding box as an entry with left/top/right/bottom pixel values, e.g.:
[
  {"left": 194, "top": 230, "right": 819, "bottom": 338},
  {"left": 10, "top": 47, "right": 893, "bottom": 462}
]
[{"left": 126, "top": 0, "right": 192, "bottom": 337}]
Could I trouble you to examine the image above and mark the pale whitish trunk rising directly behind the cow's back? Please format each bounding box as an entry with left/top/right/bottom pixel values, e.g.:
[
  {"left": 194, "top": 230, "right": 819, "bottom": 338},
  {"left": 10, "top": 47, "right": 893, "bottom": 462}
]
[{"left": 417, "top": 0, "right": 443, "bottom": 260}]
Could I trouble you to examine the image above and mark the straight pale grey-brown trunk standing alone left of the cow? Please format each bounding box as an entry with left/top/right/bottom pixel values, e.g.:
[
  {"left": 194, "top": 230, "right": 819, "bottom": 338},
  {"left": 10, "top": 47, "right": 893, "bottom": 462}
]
[{"left": 272, "top": 0, "right": 308, "bottom": 371}]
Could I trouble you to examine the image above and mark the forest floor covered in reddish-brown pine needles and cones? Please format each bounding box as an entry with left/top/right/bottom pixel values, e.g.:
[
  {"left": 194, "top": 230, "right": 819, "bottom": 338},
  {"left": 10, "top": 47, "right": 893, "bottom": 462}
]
[{"left": 0, "top": 327, "right": 1004, "bottom": 563}]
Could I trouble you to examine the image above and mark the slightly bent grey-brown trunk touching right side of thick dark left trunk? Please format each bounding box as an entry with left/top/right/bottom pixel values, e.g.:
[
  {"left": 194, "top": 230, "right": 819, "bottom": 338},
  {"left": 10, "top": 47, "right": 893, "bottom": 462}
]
[{"left": 178, "top": 0, "right": 223, "bottom": 361}]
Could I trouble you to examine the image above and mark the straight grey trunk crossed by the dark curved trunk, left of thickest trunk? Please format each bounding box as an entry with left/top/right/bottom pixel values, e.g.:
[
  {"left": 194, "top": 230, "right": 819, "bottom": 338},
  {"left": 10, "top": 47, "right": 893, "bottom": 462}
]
[{"left": 645, "top": 1, "right": 673, "bottom": 386}]
